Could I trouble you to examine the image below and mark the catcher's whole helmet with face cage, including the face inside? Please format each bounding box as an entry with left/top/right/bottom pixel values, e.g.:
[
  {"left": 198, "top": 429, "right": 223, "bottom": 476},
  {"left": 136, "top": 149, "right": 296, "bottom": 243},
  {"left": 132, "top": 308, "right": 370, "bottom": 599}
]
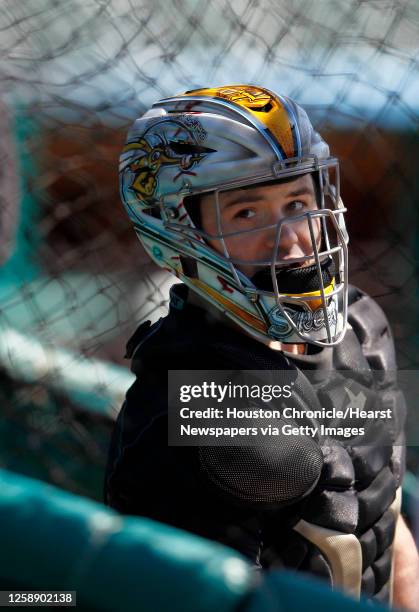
[{"left": 120, "top": 85, "right": 348, "bottom": 346}]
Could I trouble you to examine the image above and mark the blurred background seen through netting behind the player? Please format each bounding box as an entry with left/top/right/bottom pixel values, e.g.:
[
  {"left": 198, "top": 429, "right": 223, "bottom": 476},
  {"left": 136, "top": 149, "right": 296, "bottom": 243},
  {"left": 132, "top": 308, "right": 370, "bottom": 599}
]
[{"left": 0, "top": 0, "right": 419, "bottom": 536}]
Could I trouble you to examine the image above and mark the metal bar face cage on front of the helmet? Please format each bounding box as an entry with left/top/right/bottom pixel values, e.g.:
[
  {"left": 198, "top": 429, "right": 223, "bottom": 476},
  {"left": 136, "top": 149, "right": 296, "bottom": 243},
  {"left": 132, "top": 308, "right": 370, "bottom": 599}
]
[{"left": 159, "top": 156, "right": 348, "bottom": 346}]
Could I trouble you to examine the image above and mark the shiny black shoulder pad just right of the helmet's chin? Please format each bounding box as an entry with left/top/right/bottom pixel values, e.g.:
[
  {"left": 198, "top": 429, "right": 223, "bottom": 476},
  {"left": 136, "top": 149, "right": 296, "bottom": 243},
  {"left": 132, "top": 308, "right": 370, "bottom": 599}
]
[{"left": 348, "top": 287, "right": 397, "bottom": 372}]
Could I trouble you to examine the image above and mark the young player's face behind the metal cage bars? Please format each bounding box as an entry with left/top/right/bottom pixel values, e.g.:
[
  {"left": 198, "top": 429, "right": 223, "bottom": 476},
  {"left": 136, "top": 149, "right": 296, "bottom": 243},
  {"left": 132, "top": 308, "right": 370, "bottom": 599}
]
[{"left": 201, "top": 174, "right": 321, "bottom": 278}]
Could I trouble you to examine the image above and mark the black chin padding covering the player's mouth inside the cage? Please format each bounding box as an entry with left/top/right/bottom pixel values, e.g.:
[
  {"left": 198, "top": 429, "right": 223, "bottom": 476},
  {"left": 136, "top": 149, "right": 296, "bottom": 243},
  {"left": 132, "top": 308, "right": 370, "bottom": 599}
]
[{"left": 251, "top": 257, "right": 336, "bottom": 294}]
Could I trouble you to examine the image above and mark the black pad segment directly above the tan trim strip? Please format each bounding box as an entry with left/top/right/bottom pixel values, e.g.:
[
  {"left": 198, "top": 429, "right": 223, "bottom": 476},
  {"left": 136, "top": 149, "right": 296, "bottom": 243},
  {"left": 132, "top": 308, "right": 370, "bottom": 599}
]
[{"left": 303, "top": 490, "right": 358, "bottom": 533}]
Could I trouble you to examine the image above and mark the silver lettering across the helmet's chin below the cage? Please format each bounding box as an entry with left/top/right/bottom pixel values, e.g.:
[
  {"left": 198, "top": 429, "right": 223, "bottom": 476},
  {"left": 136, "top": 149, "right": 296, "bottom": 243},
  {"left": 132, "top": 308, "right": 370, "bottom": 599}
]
[{"left": 269, "top": 300, "right": 338, "bottom": 339}]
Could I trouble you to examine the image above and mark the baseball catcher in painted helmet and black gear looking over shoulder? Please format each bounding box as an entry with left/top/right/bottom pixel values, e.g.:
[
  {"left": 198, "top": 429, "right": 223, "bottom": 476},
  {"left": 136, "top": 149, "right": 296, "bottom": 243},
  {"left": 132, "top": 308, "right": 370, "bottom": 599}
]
[{"left": 105, "top": 85, "right": 419, "bottom": 609}]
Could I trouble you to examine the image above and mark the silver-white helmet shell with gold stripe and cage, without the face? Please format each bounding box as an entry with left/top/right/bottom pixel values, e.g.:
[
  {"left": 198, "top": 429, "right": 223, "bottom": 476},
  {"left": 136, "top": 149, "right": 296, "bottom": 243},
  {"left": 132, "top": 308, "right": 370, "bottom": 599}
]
[{"left": 120, "top": 85, "right": 348, "bottom": 346}]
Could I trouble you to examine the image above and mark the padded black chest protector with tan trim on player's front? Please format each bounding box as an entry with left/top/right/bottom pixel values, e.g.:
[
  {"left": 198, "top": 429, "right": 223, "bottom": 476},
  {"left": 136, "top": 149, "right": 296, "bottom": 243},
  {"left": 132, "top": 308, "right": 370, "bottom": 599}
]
[{"left": 262, "top": 288, "right": 406, "bottom": 603}]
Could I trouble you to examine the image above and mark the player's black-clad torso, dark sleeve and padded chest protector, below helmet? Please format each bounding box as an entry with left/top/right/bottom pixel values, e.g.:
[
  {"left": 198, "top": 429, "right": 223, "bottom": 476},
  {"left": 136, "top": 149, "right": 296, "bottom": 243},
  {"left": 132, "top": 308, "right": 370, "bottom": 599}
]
[{"left": 105, "top": 285, "right": 405, "bottom": 602}]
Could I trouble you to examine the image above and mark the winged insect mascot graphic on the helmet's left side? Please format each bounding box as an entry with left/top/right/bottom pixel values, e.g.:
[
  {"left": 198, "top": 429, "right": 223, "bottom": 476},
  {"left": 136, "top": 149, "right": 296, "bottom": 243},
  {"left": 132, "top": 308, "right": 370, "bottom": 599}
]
[{"left": 123, "top": 120, "right": 213, "bottom": 201}]
